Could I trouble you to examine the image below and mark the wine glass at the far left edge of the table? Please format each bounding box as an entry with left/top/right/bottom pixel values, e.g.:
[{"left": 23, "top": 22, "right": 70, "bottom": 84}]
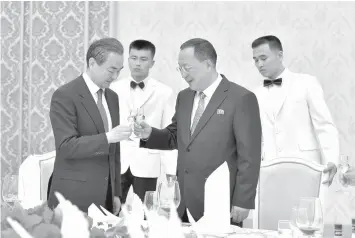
[{"left": 1, "top": 174, "right": 18, "bottom": 208}]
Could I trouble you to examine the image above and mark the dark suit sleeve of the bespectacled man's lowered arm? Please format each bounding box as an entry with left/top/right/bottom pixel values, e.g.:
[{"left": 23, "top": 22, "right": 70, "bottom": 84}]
[{"left": 232, "top": 92, "right": 261, "bottom": 209}]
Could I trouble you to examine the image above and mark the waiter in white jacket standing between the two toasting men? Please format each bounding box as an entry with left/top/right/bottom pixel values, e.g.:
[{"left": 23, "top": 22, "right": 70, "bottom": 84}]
[{"left": 110, "top": 40, "right": 177, "bottom": 203}]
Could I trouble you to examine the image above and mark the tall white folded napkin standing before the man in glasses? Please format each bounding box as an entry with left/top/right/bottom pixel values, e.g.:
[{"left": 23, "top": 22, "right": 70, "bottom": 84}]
[{"left": 191, "top": 162, "right": 231, "bottom": 234}]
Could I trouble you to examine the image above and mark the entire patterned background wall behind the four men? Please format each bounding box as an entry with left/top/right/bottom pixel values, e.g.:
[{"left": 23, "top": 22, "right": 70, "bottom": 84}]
[{"left": 0, "top": 1, "right": 355, "bottom": 222}]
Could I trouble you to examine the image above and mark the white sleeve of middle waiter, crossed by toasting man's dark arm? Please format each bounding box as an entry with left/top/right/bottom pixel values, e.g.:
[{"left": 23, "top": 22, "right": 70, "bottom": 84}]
[{"left": 161, "top": 90, "right": 177, "bottom": 175}]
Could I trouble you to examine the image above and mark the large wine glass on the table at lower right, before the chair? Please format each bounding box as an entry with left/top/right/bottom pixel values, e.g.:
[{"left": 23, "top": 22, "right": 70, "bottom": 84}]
[{"left": 296, "top": 198, "right": 323, "bottom": 237}]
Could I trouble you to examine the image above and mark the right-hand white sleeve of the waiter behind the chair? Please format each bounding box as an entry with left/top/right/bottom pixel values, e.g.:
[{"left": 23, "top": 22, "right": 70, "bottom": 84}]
[{"left": 307, "top": 77, "right": 339, "bottom": 165}]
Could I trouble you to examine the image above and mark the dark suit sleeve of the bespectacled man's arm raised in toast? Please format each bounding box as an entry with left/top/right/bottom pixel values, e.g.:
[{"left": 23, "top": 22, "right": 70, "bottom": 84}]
[{"left": 140, "top": 93, "right": 180, "bottom": 150}]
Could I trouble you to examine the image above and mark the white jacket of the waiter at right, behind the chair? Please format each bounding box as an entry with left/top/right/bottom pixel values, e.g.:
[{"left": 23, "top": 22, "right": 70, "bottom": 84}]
[{"left": 254, "top": 69, "right": 339, "bottom": 164}]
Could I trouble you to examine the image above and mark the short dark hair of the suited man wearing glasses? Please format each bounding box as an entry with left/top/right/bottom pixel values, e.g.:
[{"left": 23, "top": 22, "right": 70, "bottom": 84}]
[{"left": 180, "top": 38, "right": 217, "bottom": 66}]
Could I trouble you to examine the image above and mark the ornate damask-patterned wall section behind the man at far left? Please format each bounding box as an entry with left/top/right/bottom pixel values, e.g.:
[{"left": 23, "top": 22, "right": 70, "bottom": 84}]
[{"left": 1, "top": 1, "right": 110, "bottom": 182}]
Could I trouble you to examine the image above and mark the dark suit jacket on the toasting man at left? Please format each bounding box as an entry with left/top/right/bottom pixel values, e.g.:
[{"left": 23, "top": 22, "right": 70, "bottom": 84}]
[{"left": 48, "top": 76, "right": 121, "bottom": 212}]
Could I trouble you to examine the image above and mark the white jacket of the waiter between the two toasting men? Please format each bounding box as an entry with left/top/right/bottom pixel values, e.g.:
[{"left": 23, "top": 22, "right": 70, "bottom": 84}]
[{"left": 110, "top": 78, "right": 177, "bottom": 178}]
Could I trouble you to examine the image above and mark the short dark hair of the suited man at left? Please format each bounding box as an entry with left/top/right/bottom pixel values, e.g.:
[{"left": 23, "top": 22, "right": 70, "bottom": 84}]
[{"left": 86, "top": 38, "right": 123, "bottom": 67}]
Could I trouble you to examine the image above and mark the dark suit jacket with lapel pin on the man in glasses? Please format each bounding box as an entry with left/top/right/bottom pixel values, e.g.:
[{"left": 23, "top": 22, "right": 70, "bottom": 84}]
[{"left": 141, "top": 75, "right": 261, "bottom": 219}]
